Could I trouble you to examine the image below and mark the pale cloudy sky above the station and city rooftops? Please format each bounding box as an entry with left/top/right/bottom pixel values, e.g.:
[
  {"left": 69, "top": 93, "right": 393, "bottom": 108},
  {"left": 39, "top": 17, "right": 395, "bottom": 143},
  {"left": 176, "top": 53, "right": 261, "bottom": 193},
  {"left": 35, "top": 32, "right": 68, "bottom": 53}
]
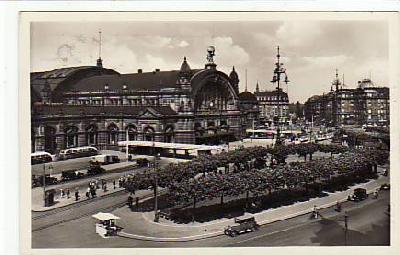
[{"left": 31, "top": 20, "right": 389, "bottom": 102}]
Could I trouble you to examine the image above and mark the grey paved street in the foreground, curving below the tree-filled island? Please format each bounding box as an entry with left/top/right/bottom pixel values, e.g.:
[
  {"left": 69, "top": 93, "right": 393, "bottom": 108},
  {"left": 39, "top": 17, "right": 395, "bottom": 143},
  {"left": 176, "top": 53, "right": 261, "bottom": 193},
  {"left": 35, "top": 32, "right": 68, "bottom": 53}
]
[{"left": 32, "top": 191, "right": 390, "bottom": 248}]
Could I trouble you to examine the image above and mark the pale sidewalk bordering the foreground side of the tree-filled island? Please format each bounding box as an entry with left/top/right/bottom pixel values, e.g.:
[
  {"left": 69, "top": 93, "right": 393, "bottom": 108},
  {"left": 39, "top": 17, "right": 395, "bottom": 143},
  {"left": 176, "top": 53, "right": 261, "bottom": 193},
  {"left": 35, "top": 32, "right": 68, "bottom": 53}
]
[{"left": 113, "top": 168, "right": 389, "bottom": 242}]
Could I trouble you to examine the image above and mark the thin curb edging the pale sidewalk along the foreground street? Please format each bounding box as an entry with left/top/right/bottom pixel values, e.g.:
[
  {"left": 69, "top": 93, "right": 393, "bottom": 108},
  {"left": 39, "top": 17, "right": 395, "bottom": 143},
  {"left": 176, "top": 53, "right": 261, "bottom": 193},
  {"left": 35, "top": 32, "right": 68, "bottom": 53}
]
[{"left": 117, "top": 177, "right": 384, "bottom": 242}]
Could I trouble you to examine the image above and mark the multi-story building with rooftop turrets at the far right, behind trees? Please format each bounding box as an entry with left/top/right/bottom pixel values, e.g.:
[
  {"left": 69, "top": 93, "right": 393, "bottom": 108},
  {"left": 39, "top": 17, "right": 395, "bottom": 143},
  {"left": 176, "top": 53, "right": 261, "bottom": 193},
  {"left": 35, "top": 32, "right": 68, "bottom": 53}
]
[{"left": 305, "top": 74, "right": 390, "bottom": 126}]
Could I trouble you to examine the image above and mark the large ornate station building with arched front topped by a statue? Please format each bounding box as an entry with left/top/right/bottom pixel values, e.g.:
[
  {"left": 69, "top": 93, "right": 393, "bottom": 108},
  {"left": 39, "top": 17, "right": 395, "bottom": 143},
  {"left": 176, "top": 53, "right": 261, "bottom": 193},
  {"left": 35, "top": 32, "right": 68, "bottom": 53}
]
[{"left": 31, "top": 47, "right": 244, "bottom": 152}]
